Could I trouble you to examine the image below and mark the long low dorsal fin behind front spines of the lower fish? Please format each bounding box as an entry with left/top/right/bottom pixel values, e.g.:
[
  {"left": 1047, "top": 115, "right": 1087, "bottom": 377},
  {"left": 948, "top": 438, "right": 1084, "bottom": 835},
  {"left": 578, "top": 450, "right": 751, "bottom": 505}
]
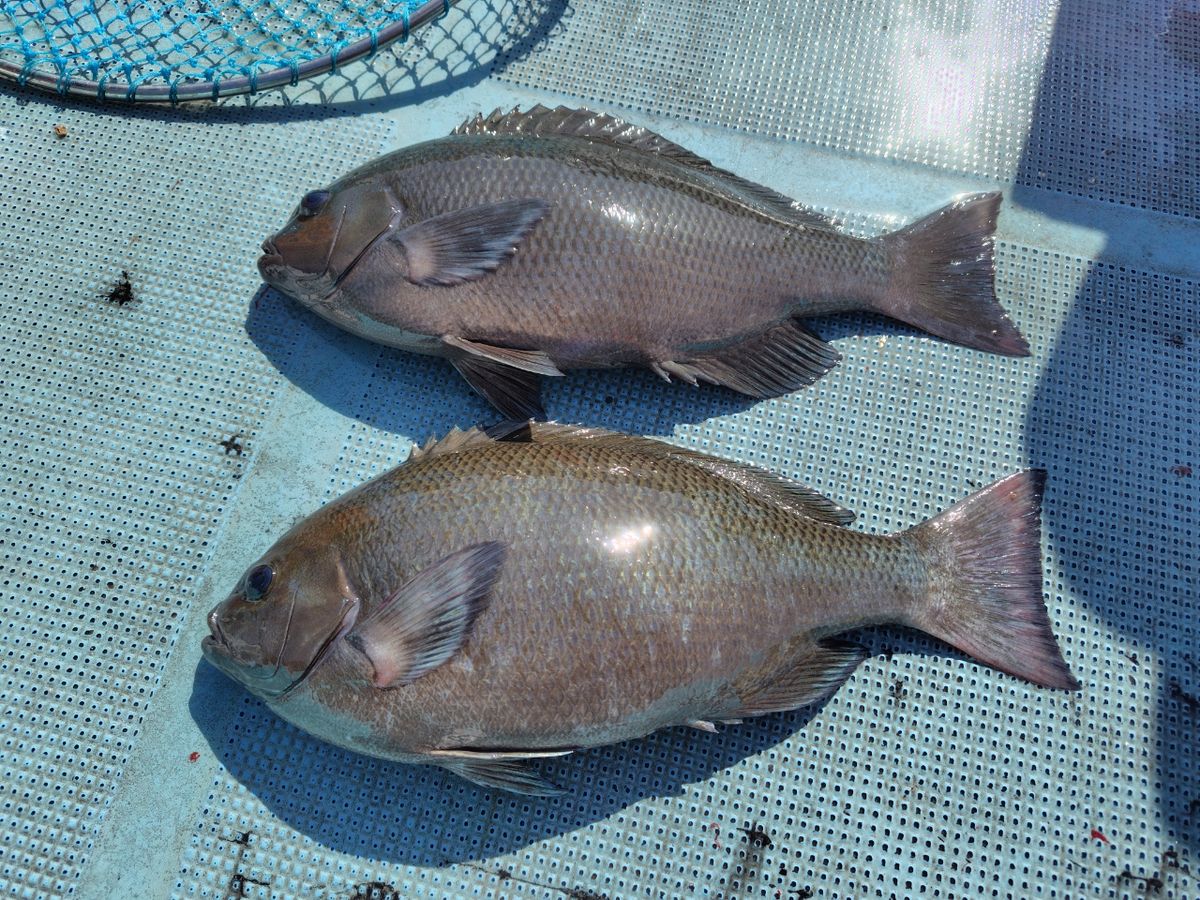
[{"left": 487, "top": 422, "right": 854, "bottom": 524}]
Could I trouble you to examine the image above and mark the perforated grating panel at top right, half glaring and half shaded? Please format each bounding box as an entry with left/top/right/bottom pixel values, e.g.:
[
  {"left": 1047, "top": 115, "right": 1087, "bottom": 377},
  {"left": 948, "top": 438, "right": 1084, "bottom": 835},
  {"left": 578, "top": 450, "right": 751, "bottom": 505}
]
[{"left": 500, "top": 0, "right": 1200, "bottom": 215}]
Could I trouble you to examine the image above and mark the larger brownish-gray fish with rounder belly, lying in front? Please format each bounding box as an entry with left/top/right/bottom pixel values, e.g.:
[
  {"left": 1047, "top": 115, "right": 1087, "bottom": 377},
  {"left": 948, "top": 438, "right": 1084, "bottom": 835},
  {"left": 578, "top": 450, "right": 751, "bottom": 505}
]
[{"left": 204, "top": 424, "right": 1079, "bottom": 794}]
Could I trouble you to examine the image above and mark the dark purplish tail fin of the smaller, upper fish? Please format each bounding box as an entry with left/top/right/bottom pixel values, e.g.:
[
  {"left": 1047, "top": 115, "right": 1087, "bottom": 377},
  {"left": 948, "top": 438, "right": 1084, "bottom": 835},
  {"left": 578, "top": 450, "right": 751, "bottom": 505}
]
[{"left": 878, "top": 192, "right": 1030, "bottom": 356}]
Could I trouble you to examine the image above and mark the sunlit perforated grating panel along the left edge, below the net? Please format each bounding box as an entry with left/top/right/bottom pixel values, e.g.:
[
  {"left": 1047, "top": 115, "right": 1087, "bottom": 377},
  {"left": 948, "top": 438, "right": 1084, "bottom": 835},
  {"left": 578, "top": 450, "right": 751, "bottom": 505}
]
[{"left": 0, "top": 103, "right": 390, "bottom": 894}]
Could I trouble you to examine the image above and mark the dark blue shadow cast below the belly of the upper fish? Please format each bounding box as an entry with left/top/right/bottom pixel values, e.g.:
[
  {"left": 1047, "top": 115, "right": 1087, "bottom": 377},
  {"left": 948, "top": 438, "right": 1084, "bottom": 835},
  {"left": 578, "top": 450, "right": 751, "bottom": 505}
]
[{"left": 246, "top": 286, "right": 777, "bottom": 439}]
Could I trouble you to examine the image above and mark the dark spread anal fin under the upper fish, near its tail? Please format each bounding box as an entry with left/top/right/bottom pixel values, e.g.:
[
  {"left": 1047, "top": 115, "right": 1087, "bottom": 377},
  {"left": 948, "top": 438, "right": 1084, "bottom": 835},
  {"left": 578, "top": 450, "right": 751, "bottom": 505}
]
[{"left": 667, "top": 319, "right": 841, "bottom": 400}]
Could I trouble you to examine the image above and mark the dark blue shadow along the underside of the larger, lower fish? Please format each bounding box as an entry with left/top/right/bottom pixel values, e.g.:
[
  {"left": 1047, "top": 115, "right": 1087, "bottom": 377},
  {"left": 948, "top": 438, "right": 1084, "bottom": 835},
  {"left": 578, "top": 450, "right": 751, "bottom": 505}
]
[{"left": 188, "top": 629, "right": 936, "bottom": 868}]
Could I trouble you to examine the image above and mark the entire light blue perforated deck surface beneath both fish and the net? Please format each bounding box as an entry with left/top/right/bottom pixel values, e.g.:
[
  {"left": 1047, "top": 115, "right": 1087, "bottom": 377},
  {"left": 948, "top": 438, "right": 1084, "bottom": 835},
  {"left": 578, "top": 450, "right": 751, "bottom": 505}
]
[{"left": 0, "top": 0, "right": 1200, "bottom": 900}]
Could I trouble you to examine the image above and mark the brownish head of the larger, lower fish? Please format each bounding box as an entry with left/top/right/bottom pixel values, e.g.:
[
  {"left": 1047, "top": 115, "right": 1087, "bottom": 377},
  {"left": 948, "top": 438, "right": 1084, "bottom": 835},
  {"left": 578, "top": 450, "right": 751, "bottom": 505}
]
[{"left": 203, "top": 538, "right": 359, "bottom": 700}]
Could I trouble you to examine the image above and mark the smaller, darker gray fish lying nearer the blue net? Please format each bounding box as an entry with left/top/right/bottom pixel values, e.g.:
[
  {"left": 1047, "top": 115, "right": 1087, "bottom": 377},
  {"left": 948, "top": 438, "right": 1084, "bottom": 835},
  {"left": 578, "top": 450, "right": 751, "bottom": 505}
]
[{"left": 258, "top": 107, "right": 1028, "bottom": 419}]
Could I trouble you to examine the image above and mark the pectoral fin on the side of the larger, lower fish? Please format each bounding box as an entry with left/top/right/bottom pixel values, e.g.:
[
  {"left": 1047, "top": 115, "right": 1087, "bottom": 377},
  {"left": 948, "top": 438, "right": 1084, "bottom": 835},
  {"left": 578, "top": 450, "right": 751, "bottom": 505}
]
[{"left": 344, "top": 541, "right": 505, "bottom": 688}]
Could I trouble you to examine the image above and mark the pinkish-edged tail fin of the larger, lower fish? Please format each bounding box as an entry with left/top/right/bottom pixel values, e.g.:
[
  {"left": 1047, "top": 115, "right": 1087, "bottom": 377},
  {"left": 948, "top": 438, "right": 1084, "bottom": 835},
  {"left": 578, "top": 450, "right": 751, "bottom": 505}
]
[{"left": 908, "top": 469, "right": 1079, "bottom": 690}]
